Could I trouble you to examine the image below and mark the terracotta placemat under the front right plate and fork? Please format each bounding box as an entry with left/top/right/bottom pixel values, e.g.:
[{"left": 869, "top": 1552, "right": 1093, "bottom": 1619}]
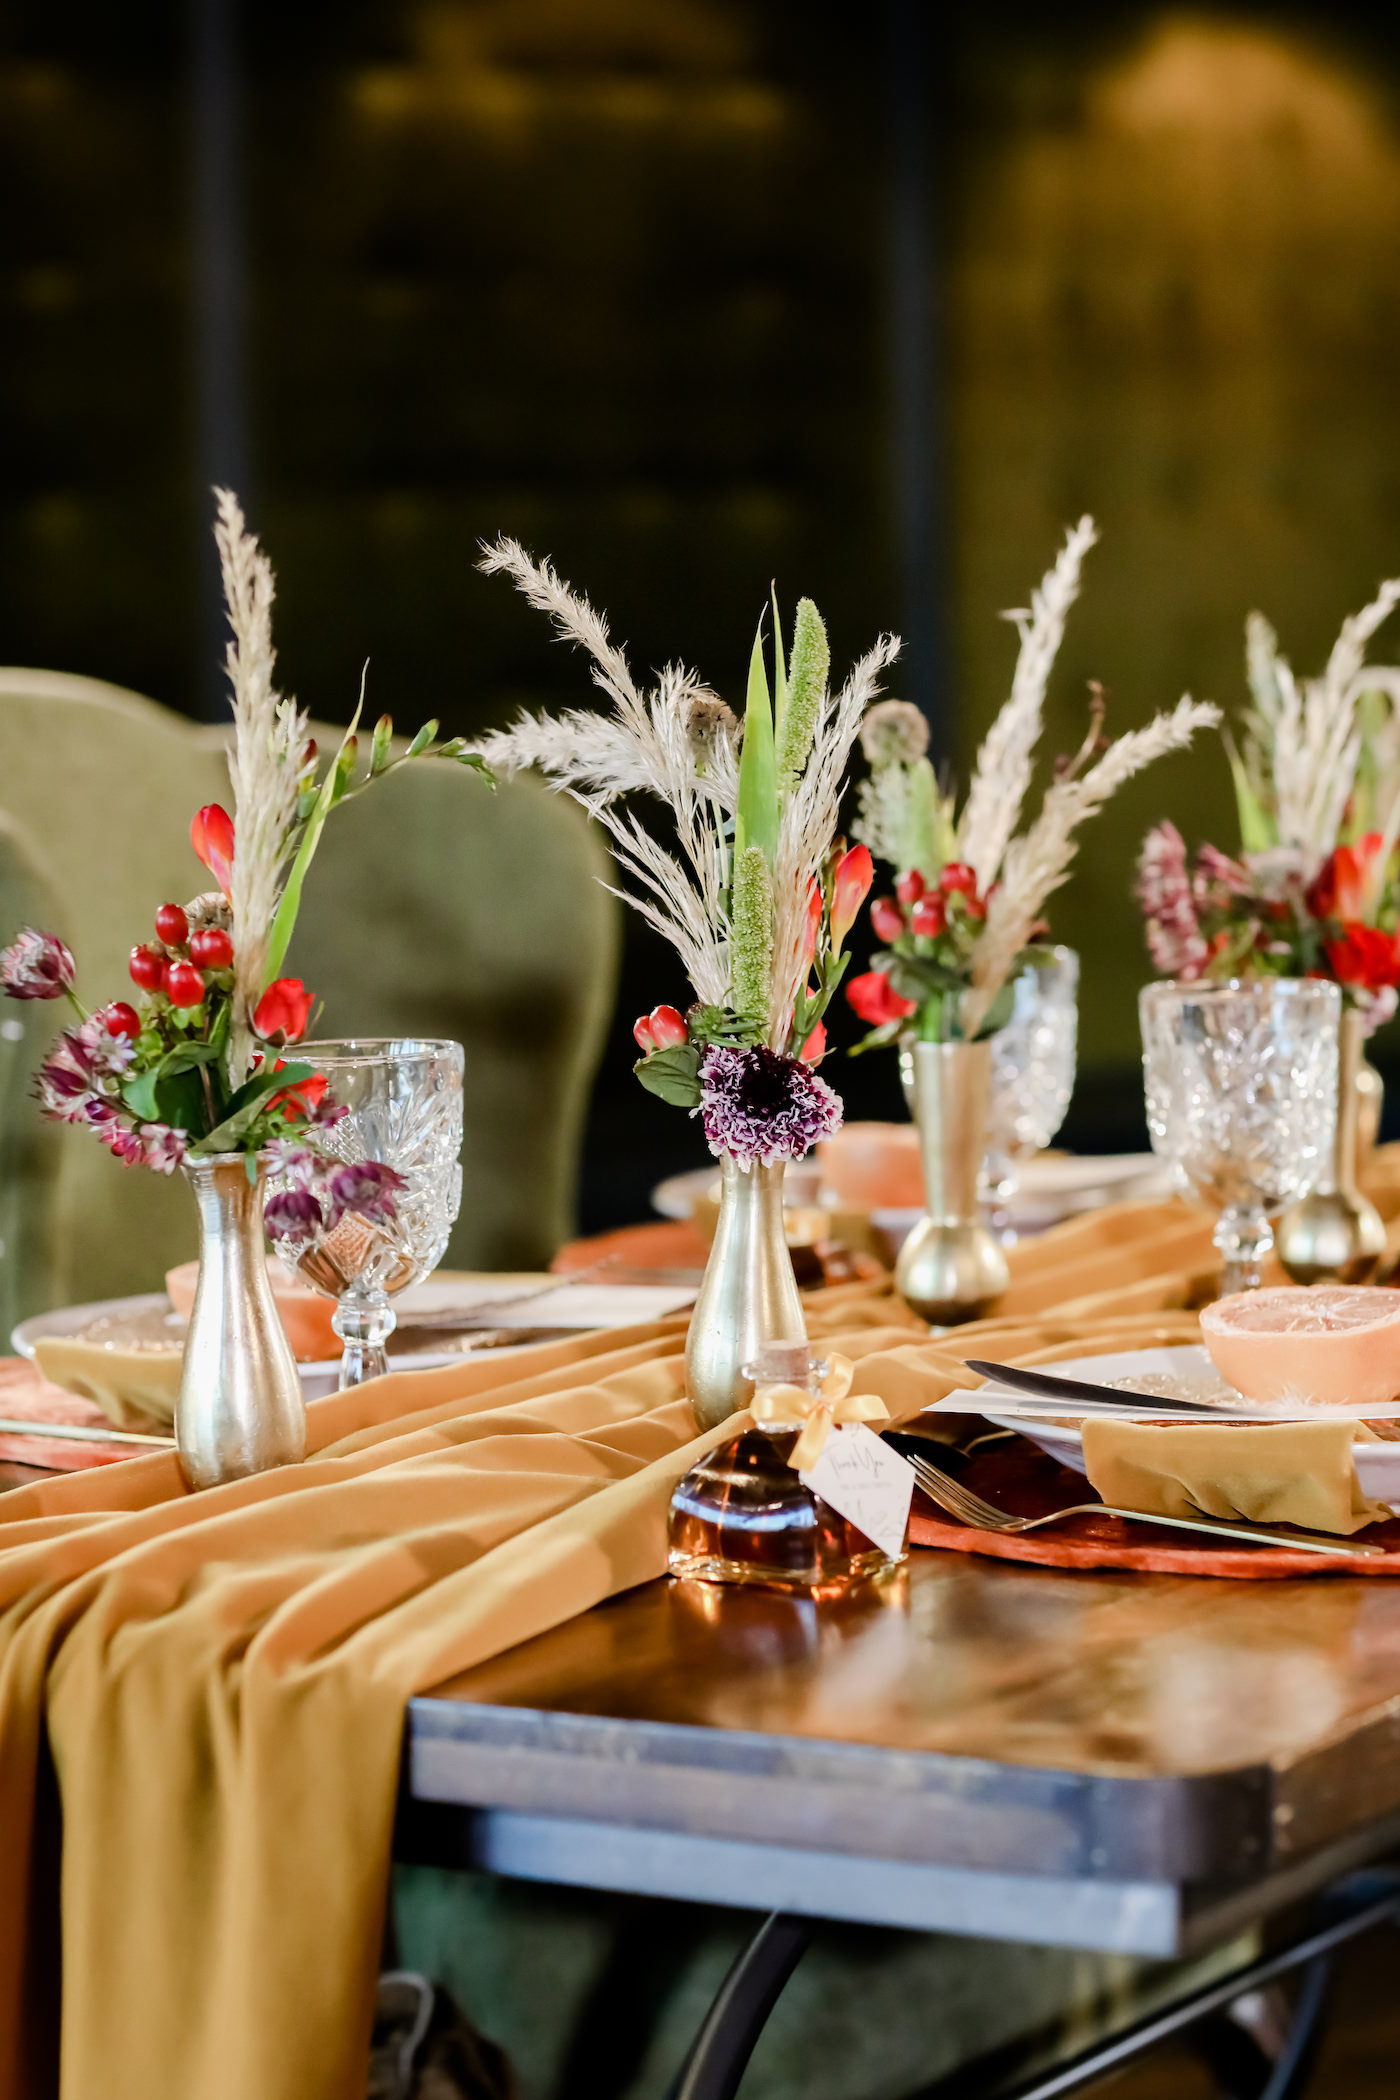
[{"left": 909, "top": 1439, "right": 1400, "bottom": 1581}]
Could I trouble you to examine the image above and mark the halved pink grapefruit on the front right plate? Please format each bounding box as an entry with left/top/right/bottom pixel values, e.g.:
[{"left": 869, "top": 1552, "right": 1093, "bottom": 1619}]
[{"left": 1201, "top": 1283, "right": 1400, "bottom": 1407}]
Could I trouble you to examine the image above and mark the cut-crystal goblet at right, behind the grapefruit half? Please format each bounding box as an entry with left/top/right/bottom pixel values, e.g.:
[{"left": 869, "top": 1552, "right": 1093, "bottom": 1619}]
[{"left": 1138, "top": 977, "right": 1341, "bottom": 1292}]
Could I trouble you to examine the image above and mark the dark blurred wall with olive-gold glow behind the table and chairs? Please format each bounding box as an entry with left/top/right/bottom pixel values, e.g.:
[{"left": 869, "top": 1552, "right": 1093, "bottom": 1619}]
[{"left": 0, "top": 0, "right": 1400, "bottom": 1229}]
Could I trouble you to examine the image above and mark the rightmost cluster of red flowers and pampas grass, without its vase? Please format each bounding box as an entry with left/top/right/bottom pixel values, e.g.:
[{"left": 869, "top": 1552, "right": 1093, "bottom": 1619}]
[{"left": 1138, "top": 580, "right": 1400, "bottom": 1033}]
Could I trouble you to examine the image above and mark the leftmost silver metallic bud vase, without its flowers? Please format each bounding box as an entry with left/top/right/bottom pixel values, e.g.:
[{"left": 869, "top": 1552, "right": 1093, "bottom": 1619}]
[{"left": 174, "top": 1153, "right": 306, "bottom": 1487}]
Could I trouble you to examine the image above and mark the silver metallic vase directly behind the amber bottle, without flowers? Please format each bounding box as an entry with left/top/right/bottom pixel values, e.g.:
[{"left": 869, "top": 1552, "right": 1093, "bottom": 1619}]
[{"left": 686, "top": 1153, "right": 806, "bottom": 1430}]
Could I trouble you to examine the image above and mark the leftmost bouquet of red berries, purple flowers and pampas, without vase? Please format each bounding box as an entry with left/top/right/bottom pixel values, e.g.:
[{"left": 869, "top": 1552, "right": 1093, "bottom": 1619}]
[{"left": 0, "top": 489, "right": 485, "bottom": 1235}]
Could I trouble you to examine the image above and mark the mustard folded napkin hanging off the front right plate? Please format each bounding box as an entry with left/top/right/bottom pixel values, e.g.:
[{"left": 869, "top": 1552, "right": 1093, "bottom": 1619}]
[{"left": 1081, "top": 1418, "right": 1390, "bottom": 1537}]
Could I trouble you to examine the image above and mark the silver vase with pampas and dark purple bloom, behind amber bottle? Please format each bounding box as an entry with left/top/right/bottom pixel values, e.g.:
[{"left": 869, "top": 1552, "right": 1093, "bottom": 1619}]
[{"left": 476, "top": 540, "right": 898, "bottom": 1424}]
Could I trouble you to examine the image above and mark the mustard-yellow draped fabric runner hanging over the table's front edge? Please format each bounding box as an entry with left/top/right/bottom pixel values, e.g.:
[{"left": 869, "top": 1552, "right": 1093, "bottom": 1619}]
[{"left": 0, "top": 1203, "right": 1309, "bottom": 2100}]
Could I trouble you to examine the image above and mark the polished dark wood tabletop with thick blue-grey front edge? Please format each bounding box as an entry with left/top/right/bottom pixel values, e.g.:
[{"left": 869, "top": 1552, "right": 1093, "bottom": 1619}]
[{"left": 405, "top": 1552, "right": 1400, "bottom": 1953}]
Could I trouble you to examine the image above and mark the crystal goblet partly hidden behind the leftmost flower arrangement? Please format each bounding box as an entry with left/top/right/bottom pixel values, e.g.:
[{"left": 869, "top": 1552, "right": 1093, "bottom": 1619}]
[{"left": 273, "top": 1037, "right": 466, "bottom": 1386}]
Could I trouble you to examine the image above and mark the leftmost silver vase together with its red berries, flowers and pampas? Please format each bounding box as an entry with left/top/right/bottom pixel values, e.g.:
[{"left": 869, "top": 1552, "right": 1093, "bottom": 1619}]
[{"left": 0, "top": 489, "right": 487, "bottom": 1487}]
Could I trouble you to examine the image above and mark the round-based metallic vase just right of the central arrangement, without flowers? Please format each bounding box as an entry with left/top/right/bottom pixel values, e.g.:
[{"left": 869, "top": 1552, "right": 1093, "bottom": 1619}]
[{"left": 894, "top": 1042, "right": 1010, "bottom": 1325}]
